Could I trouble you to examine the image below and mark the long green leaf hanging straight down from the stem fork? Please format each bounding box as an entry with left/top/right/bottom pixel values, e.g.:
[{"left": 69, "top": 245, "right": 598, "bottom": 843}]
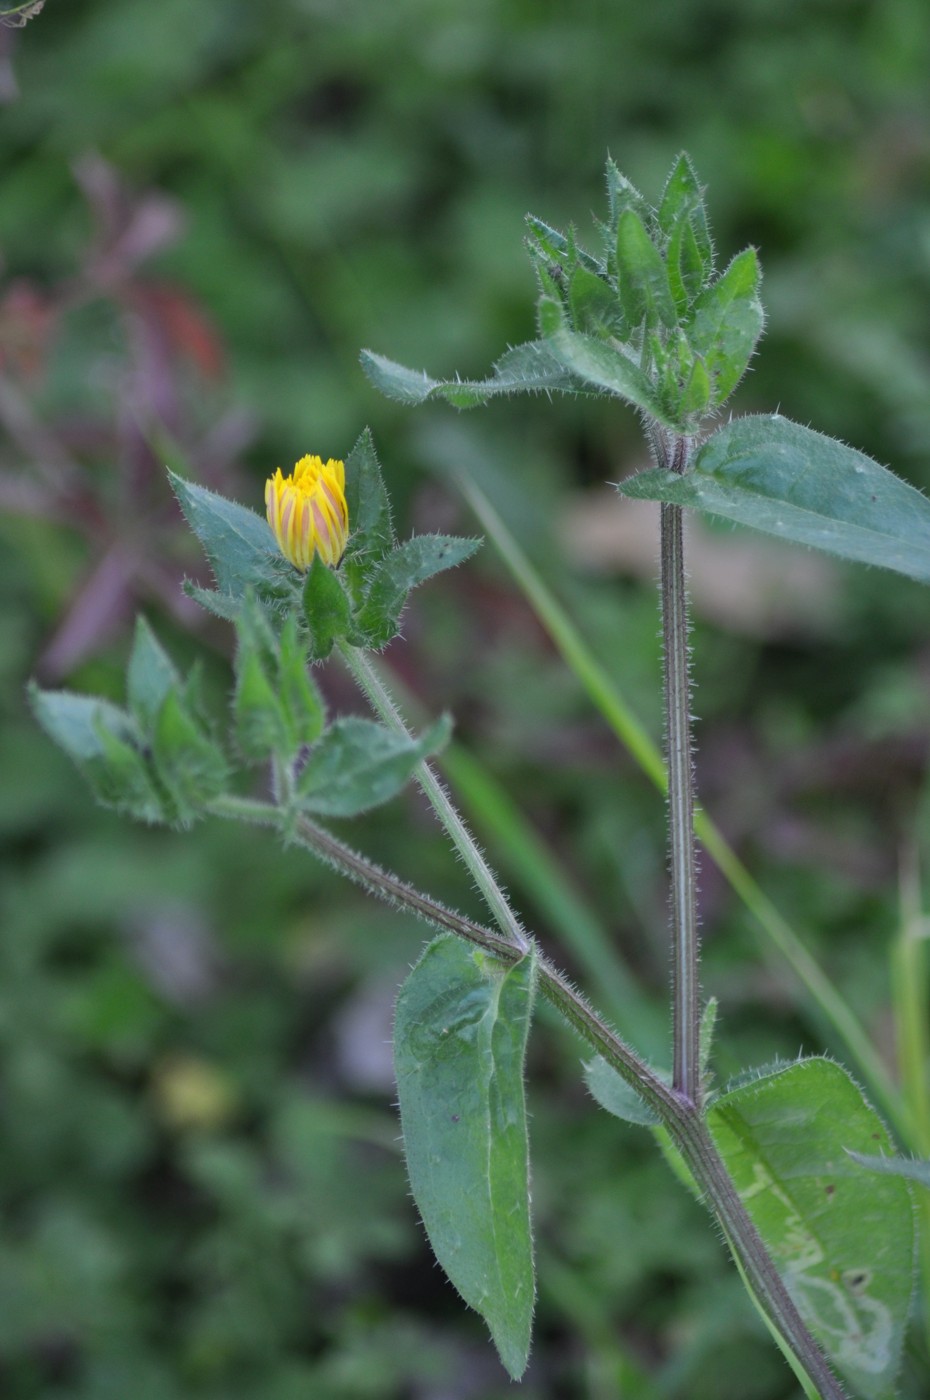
[{"left": 394, "top": 938, "right": 535, "bottom": 1380}]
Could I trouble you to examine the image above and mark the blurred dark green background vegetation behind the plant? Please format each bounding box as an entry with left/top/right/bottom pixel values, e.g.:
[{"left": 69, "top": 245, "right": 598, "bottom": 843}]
[{"left": 0, "top": 0, "right": 930, "bottom": 1400}]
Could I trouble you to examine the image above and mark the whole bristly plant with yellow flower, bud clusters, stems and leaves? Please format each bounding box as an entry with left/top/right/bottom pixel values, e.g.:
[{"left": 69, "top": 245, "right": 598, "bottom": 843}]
[{"left": 32, "top": 155, "right": 930, "bottom": 1400}]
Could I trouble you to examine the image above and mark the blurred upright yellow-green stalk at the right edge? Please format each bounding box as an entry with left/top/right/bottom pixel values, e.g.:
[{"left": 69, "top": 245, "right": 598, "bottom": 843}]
[{"left": 891, "top": 853, "right": 930, "bottom": 1347}]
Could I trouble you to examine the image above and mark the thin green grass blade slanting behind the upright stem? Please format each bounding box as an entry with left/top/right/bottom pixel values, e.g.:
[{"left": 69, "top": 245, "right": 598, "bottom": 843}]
[{"left": 458, "top": 479, "right": 913, "bottom": 1147}]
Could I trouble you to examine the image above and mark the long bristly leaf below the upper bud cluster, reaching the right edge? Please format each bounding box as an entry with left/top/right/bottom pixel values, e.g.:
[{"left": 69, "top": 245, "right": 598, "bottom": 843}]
[{"left": 619, "top": 414, "right": 930, "bottom": 584}]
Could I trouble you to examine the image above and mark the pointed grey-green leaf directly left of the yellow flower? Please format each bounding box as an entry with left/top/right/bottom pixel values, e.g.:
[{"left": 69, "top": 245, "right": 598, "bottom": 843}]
[{"left": 168, "top": 472, "right": 283, "bottom": 598}]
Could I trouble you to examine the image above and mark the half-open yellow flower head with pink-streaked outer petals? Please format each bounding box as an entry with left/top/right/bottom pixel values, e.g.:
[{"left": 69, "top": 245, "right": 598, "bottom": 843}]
[{"left": 265, "top": 456, "right": 349, "bottom": 568}]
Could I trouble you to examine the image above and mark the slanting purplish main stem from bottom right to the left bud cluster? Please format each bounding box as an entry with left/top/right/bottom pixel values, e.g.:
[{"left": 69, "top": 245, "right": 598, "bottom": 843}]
[{"left": 209, "top": 797, "right": 843, "bottom": 1400}]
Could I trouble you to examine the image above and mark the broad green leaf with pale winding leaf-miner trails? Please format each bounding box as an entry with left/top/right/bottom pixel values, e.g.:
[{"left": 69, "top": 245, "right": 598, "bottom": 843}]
[{"left": 707, "top": 1060, "right": 915, "bottom": 1400}]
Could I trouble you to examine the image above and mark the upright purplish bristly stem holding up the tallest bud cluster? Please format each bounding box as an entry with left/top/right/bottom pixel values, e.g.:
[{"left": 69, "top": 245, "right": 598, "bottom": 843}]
[{"left": 660, "top": 438, "right": 700, "bottom": 1107}]
